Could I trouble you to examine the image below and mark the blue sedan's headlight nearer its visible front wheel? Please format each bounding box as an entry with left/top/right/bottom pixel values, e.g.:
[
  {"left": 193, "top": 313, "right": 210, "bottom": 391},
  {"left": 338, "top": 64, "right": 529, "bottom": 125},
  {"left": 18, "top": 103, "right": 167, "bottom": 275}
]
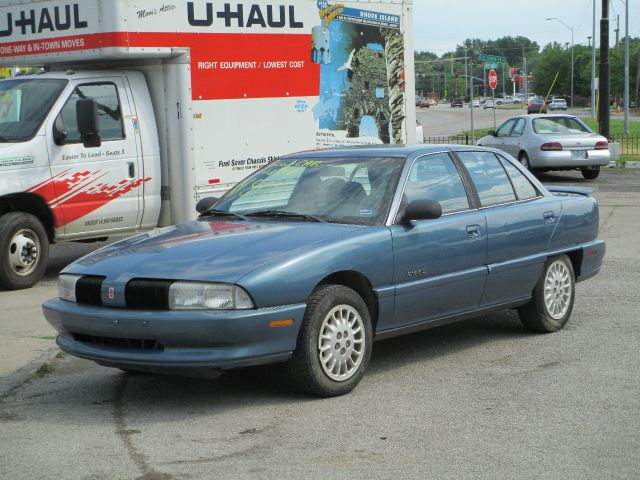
[{"left": 169, "top": 282, "right": 255, "bottom": 310}]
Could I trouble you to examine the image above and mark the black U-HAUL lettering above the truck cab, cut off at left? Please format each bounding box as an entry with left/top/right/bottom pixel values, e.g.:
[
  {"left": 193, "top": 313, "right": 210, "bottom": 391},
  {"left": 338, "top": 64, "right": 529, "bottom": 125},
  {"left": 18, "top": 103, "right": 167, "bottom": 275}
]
[{"left": 0, "top": 3, "right": 89, "bottom": 37}]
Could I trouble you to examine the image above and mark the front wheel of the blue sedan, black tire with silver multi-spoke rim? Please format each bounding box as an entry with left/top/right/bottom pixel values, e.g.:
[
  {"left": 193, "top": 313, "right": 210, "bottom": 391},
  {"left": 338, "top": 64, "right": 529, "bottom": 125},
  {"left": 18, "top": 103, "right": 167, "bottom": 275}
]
[{"left": 289, "top": 285, "right": 373, "bottom": 397}]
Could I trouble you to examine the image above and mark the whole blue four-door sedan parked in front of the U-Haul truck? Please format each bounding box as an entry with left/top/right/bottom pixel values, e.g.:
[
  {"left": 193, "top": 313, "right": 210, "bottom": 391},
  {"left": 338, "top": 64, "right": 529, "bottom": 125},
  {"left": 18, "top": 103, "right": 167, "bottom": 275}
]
[{"left": 44, "top": 145, "right": 605, "bottom": 396}]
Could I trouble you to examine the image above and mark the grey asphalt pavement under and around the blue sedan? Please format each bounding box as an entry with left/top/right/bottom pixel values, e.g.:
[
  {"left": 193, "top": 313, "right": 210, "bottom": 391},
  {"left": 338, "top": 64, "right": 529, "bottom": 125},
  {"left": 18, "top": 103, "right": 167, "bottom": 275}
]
[{"left": 0, "top": 169, "right": 640, "bottom": 480}]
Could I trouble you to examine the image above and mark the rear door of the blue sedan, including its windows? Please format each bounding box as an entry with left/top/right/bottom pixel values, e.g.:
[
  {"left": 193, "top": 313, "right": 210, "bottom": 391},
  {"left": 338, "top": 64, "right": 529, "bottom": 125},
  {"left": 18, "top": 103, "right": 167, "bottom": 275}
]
[{"left": 457, "top": 152, "right": 561, "bottom": 307}]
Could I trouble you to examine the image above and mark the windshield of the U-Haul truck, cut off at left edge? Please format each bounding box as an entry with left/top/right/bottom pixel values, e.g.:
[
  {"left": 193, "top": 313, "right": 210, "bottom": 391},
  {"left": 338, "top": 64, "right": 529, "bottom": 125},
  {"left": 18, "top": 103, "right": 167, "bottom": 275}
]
[{"left": 0, "top": 78, "right": 67, "bottom": 142}]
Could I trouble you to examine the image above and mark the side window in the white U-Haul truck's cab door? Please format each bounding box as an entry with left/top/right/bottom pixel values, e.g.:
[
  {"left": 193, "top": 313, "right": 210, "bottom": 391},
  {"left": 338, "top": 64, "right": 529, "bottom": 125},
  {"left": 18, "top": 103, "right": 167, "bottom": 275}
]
[{"left": 60, "top": 83, "right": 124, "bottom": 143}]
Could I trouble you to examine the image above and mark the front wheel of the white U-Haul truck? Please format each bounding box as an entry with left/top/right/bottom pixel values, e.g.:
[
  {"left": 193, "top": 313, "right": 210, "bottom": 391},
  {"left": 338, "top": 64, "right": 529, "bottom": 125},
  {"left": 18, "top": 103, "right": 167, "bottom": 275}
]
[{"left": 0, "top": 212, "right": 49, "bottom": 290}]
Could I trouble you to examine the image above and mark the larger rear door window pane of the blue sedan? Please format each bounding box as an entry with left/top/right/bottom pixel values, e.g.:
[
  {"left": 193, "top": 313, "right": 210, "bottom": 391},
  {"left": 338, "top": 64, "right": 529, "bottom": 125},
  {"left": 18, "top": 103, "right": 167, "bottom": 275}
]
[{"left": 457, "top": 152, "right": 516, "bottom": 207}]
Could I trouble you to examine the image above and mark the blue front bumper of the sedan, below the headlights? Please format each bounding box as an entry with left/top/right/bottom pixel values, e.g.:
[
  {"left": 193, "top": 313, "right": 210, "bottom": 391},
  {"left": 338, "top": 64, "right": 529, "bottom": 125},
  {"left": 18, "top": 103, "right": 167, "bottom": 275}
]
[{"left": 42, "top": 299, "right": 306, "bottom": 370}]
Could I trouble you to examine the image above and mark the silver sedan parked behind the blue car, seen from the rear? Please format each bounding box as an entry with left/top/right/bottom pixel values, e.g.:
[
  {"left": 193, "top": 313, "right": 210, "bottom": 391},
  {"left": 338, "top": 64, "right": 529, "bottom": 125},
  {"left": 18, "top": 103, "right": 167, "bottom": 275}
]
[{"left": 478, "top": 114, "right": 611, "bottom": 180}]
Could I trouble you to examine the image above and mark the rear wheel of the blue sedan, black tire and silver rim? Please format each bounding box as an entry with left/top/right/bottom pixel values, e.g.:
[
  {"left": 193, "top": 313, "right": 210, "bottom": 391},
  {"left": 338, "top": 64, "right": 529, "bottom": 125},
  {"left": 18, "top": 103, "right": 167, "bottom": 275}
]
[{"left": 518, "top": 255, "right": 576, "bottom": 333}]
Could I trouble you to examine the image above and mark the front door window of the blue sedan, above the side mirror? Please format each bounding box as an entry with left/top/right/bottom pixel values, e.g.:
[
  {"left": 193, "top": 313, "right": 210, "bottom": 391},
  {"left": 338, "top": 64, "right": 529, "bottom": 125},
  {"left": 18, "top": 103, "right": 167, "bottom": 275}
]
[{"left": 404, "top": 153, "right": 469, "bottom": 213}]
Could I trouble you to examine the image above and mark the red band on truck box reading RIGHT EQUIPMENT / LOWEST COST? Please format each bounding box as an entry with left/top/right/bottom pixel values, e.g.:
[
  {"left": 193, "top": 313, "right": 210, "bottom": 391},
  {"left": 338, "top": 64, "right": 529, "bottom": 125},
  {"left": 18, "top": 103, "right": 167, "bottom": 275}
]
[{"left": 0, "top": 32, "right": 320, "bottom": 100}]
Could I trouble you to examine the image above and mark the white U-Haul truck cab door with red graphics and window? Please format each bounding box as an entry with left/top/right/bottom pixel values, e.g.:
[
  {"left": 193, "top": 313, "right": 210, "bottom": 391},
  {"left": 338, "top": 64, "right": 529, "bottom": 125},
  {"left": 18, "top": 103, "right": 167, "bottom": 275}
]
[{"left": 48, "top": 77, "right": 144, "bottom": 237}]
